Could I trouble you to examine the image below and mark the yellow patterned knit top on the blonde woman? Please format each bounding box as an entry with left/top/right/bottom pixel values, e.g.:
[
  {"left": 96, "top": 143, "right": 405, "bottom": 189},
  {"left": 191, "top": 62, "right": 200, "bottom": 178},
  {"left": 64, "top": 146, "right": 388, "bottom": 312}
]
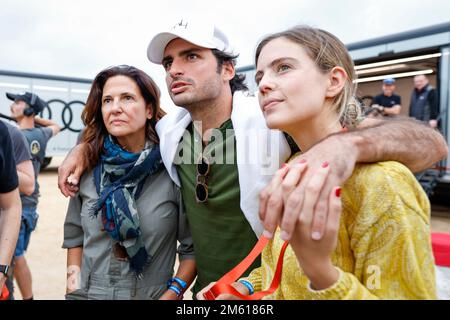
[{"left": 245, "top": 161, "right": 436, "bottom": 300}]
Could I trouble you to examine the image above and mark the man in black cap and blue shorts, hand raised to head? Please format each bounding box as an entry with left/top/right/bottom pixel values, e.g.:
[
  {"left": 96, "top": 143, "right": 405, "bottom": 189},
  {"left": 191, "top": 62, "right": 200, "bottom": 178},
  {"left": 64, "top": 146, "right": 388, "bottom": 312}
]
[{"left": 6, "top": 92, "right": 61, "bottom": 300}]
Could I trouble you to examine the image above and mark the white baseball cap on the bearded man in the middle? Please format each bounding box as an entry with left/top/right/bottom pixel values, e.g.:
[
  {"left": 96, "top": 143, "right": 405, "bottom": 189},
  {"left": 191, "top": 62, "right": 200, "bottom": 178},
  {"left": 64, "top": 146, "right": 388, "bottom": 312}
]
[{"left": 147, "top": 19, "right": 233, "bottom": 64}]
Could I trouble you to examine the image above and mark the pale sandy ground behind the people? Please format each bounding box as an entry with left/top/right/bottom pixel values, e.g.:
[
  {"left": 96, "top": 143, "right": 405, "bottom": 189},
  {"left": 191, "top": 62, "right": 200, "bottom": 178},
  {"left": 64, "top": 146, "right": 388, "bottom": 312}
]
[{"left": 8, "top": 159, "right": 450, "bottom": 300}]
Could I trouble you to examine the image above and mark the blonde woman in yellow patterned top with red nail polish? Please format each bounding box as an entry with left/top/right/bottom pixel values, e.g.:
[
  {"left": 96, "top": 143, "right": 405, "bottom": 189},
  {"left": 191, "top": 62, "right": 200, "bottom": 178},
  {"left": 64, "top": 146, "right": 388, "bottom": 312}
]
[{"left": 198, "top": 27, "right": 436, "bottom": 299}]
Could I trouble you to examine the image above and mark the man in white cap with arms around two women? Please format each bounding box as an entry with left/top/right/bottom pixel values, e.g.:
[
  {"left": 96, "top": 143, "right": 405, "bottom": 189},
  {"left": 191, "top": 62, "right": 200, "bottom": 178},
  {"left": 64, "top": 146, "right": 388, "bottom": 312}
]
[{"left": 58, "top": 20, "right": 447, "bottom": 294}]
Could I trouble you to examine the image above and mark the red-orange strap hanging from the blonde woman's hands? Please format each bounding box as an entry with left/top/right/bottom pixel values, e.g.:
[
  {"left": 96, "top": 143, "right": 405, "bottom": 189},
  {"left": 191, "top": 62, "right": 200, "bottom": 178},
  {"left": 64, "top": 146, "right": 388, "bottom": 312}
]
[{"left": 203, "top": 236, "right": 289, "bottom": 300}]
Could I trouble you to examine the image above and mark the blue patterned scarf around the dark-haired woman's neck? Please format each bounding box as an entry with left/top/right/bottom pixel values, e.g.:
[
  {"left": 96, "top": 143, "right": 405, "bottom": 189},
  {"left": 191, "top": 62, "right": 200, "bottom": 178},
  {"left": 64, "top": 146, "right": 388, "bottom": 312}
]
[{"left": 92, "top": 136, "right": 162, "bottom": 277}]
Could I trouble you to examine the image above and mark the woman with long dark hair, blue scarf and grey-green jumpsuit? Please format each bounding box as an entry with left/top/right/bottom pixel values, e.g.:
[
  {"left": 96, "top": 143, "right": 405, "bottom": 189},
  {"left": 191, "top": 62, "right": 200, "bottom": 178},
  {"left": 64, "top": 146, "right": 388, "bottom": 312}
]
[{"left": 63, "top": 66, "right": 195, "bottom": 299}]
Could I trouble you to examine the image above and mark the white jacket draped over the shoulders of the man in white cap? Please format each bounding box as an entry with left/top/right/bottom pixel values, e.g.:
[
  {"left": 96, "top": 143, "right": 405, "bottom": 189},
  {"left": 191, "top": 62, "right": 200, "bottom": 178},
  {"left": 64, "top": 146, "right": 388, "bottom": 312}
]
[{"left": 156, "top": 91, "right": 291, "bottom": 237}]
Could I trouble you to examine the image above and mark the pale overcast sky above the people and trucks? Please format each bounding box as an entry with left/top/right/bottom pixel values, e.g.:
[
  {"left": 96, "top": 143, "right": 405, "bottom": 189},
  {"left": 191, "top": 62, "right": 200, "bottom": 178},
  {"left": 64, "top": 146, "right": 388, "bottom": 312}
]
[{"left": 0, "top": 0, "right": 450, "bottom": 109}]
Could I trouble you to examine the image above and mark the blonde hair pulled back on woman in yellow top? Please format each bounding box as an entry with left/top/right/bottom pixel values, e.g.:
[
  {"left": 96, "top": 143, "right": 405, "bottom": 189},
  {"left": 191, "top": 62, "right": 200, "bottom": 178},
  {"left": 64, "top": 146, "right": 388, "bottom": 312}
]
[{"left": 255, "top": 26, "right": 362, "bottom": 128}]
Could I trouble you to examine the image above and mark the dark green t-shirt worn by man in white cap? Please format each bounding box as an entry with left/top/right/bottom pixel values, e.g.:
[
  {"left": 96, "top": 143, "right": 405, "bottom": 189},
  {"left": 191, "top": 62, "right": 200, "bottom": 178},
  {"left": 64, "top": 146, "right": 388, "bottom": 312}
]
[{"left": 177, "top": 120, "right": 261, "bottom": 295}]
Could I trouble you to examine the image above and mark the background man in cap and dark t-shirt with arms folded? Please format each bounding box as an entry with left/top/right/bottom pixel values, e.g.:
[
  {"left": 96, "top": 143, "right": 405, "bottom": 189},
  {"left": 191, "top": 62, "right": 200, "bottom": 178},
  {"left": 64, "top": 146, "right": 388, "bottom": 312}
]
[{"left": 372, "top": 78, "right": 402, "bottom": 116}]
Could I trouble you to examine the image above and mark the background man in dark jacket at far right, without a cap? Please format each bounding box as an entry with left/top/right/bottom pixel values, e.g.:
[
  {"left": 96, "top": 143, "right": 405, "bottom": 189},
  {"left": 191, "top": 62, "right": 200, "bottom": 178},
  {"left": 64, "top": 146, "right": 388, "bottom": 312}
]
[{"left": 409, "top": 74, "right": 439, "bottom": 128}]
